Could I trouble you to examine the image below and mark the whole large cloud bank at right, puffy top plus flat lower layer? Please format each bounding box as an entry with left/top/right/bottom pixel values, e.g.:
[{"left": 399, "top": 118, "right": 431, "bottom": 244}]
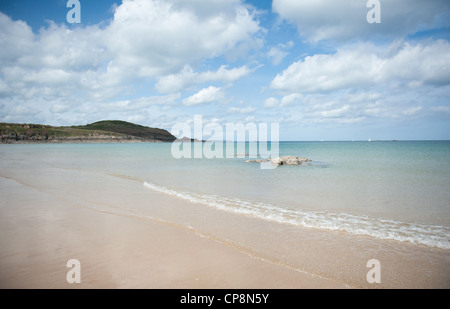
[{"left": 264, "top": 40, "right": 450, "bottom": 127}]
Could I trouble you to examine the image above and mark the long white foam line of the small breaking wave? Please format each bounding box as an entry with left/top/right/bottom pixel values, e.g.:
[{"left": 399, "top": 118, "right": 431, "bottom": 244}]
[{"left": 144, "top": 182, "right": 450, "bottom": 249}]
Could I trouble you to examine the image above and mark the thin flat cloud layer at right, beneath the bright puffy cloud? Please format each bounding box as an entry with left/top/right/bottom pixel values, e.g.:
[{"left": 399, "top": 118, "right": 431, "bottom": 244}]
[{"left": 270, "top": 87, "right": 450, "bottom": 128}]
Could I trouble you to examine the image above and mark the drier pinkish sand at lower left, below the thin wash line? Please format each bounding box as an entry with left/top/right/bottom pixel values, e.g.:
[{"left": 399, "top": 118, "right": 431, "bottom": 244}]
[{"left": 0, "top": 167, "right": 346, "bottom": 288}]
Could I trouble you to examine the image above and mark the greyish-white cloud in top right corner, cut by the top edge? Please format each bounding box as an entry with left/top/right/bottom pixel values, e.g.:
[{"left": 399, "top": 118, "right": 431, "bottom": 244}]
[{"left": 272, "top": 0, "right": 450, "bottom": 42}]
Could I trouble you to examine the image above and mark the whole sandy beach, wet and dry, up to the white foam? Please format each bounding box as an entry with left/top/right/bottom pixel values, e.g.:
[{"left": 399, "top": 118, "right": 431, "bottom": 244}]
[{"left": 0, "top": 156, "right": 450, "bottom": 289}]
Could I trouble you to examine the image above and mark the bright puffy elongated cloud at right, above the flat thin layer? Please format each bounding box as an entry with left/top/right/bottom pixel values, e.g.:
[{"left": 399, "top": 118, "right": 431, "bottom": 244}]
[{"left": 271, "top": 40, "right": 450, "bottom": 93}]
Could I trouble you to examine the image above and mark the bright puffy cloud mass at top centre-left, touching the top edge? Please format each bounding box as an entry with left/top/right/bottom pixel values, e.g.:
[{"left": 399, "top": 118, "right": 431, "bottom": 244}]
[{"left": 106, "top": 0, "right": 262, "bottom": 76}]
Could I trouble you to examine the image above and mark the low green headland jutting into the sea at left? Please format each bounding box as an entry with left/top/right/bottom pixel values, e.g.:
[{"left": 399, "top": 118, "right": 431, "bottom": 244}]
[{"left": 0, "top": 120, "right": 176, "bottom": 143}]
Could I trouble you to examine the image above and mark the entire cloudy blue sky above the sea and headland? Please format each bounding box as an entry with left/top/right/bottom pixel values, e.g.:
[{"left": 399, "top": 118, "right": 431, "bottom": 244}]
[{"left": 0, "top": 0, "right": 450, "bottom": 140}]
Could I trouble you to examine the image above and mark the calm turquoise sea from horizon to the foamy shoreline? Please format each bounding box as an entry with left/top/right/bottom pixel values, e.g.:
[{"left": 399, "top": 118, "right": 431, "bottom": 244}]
[{"left": 0, "top": 141, "right": 450, "bottom": 249}]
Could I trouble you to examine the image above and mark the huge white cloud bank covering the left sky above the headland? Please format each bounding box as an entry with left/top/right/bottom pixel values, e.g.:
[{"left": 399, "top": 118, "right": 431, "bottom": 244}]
[{"left": 0, "top": 0, "right": 264, "bottom": 122}]
